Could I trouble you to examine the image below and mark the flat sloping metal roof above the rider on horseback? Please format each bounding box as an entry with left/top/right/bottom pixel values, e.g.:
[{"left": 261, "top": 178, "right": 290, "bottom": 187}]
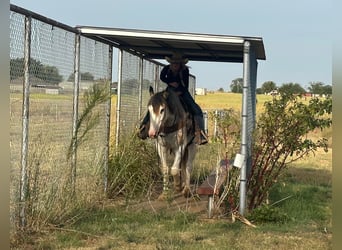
[{"left": 76, "top": 26, "right": 266, "bottom": 62}]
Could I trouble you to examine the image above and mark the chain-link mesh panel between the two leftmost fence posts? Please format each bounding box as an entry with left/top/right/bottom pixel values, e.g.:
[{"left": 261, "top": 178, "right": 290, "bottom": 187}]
[{"left": 29, "top": 16, "right": 75, "bottom": 172}]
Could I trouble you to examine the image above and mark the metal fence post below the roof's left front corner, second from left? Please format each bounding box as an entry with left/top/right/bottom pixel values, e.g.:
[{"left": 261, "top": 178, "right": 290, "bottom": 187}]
[{"left": 70, "top": 34, "right": 81, "bottom": 195}]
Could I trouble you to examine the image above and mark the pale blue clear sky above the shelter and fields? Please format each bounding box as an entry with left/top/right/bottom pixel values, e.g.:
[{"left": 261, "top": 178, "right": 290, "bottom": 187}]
[{"left": 10, "top": 0, "right": 333, "bottom": 91}]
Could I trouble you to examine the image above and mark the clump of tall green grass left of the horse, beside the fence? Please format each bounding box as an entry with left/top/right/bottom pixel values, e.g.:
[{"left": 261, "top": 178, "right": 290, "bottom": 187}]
[{"left": 107, "top": 136, "right": 161, "bottom": 199}]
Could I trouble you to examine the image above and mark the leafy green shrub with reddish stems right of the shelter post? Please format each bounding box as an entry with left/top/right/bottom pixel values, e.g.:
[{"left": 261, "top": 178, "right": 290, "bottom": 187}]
[{"left": 247, "top": 95, "right": 332, "bottom": 210}]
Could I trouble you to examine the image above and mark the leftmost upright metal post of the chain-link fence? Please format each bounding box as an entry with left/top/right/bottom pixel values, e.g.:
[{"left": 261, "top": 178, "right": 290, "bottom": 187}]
[{"left": 19, "top": 16, "right": 32, "bottom": 227}]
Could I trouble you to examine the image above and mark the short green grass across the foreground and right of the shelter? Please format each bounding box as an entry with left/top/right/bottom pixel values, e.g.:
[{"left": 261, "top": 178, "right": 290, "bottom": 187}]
[{"left": 20, "top": 162, "right": 332, "bottom": 249}]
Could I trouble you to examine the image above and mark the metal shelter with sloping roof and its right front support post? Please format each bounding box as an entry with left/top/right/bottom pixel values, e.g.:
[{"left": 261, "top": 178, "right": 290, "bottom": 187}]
[{"left": 76, "top": 26, "right": 266, "bottom": 215}]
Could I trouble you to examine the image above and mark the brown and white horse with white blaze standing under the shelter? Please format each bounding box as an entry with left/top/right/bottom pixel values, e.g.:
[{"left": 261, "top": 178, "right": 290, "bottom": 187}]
[{"left": 148, "top": 87, "right": 196, "bottom": 198}]
